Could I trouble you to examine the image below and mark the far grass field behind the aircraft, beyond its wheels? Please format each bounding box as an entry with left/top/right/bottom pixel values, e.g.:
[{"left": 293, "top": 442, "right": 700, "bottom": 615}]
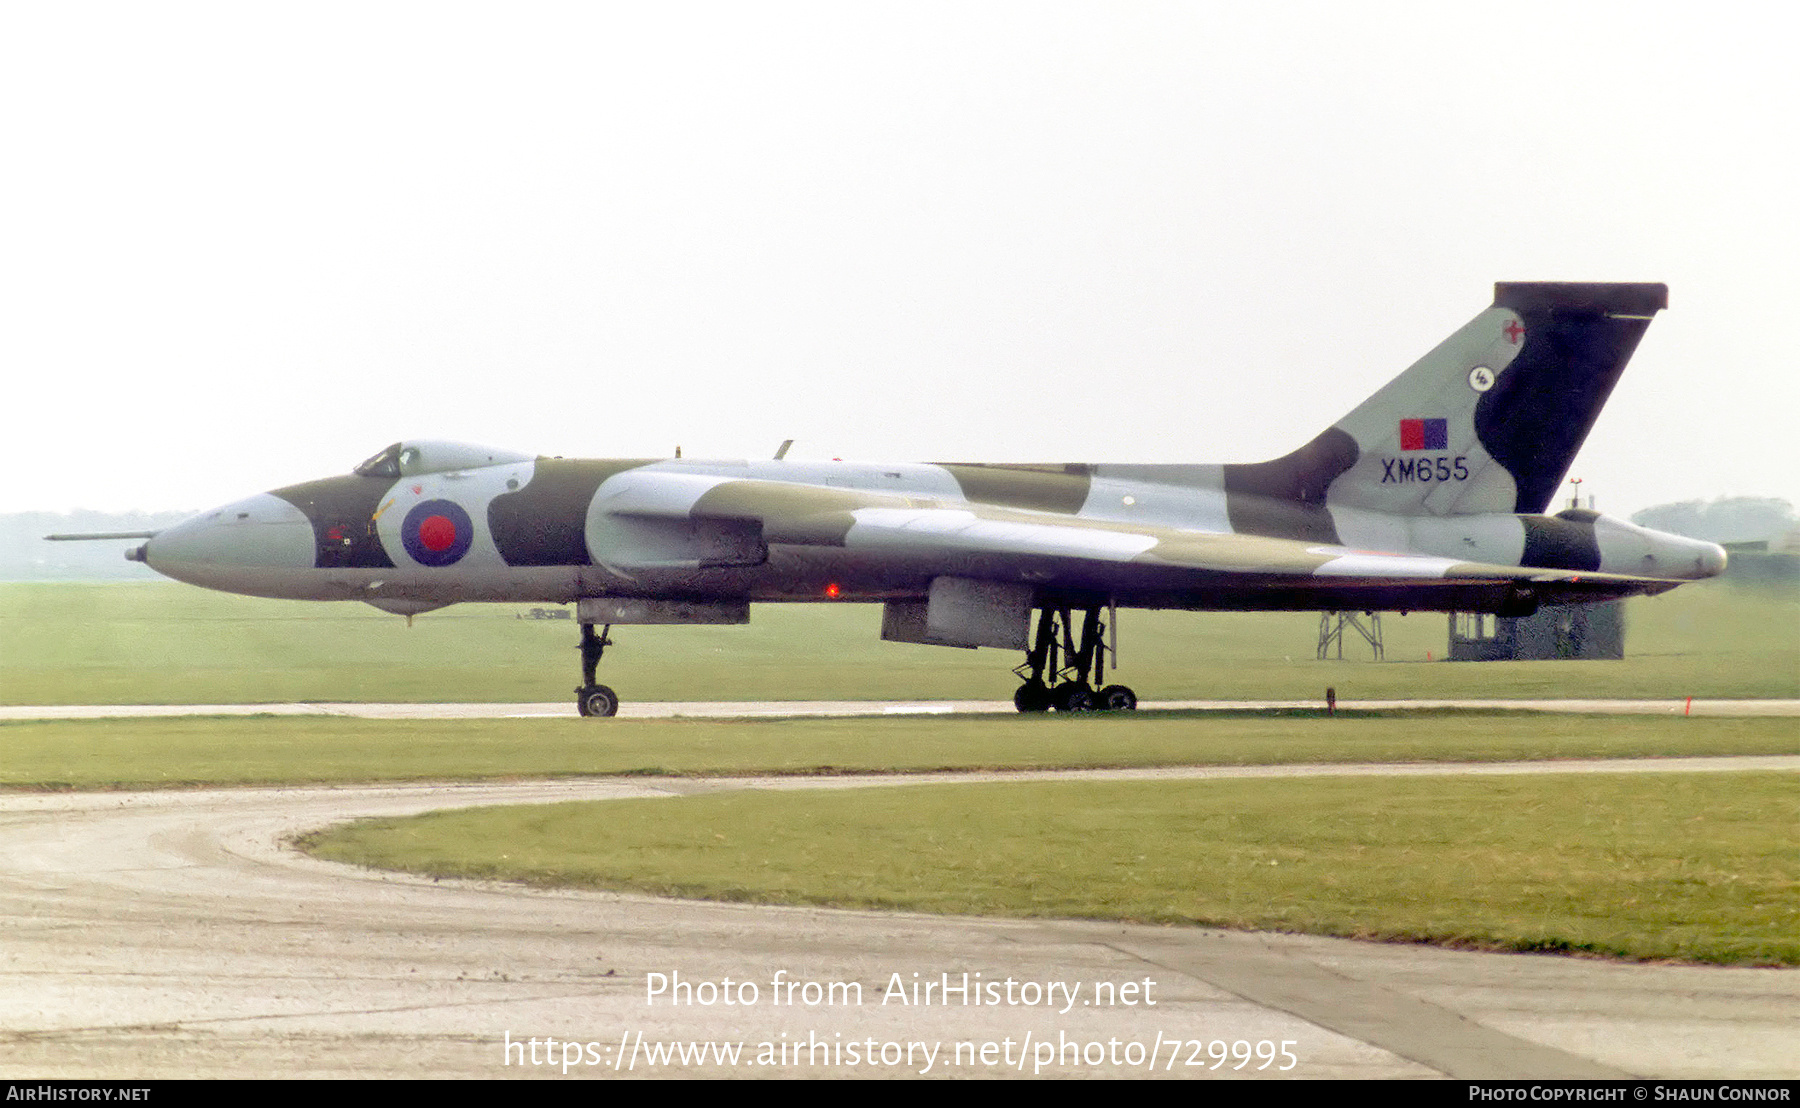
[{"left": 0, "top": 583, "right": 1800, "bottom": 703}]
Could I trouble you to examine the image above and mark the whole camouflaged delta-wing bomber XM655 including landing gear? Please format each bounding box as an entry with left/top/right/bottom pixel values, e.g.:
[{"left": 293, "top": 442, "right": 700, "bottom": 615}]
[{"left": 52, "top": 282, "right": 1724, "bottom": 716}]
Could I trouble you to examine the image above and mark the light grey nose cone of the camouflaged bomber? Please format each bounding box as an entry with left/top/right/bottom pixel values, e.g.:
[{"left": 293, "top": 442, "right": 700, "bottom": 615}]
[{"left": 140, "top": 493, "right": 315, "bottom": 595}]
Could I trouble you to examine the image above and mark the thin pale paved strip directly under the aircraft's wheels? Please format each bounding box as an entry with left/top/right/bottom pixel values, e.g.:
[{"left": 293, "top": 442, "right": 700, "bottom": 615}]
[{"left": 0, "top": 700, "right": 1800, "bottom": 719}]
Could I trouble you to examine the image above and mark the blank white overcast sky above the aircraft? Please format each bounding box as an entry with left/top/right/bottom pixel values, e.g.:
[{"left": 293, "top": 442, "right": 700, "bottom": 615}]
[{"left": 0, "top": 0, "right": 1800, "bottom": 514}]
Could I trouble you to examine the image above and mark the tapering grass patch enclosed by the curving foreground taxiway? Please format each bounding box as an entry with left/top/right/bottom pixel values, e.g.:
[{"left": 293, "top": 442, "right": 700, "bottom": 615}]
[{"left": 308, "top": 773, "right": 1800, "bottom": 964}]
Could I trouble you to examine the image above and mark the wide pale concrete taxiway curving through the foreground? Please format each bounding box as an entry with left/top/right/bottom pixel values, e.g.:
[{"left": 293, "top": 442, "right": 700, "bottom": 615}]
[{"left": 0, "top": 757, "right": 1800, "bottom": 1077}]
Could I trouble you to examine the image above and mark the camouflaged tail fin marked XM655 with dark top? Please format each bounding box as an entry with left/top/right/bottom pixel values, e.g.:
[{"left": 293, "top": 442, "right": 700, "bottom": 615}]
[{"left": 1224, "top": 282, "right": 1669, "bottom": 534}]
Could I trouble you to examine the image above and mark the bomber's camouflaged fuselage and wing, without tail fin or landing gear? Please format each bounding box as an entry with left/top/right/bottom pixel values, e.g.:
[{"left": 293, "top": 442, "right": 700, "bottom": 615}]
[{"left": 151, "top": 451, "right": 1706, "bottom": 612}]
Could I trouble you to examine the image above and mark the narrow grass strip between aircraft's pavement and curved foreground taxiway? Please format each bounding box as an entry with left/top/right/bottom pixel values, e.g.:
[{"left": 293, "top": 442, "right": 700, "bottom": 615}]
[{"left": 0, "top": 710, "right": 1800, "bottom": 788}]
